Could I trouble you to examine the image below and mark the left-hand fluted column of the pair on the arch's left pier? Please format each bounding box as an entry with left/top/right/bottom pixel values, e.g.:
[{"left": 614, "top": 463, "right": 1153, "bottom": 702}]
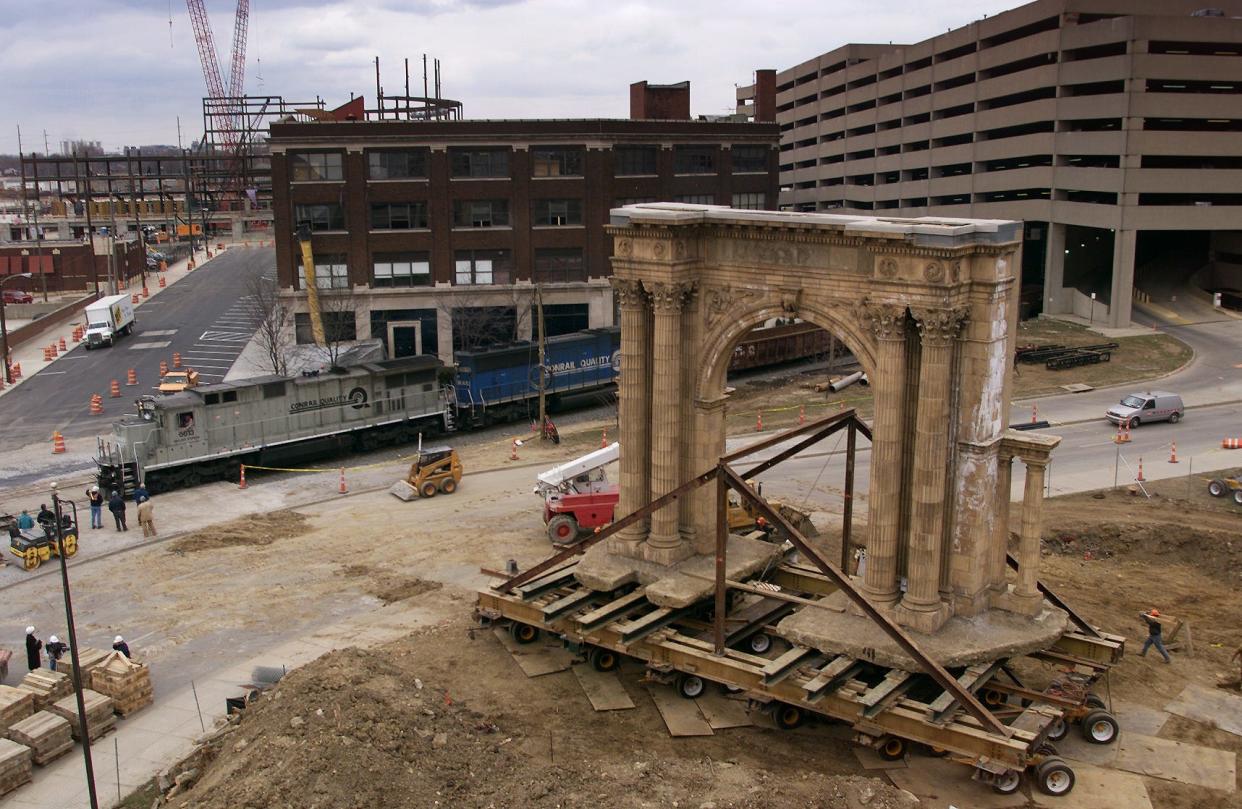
[{"left": 611, "top": 277, "right": 651, "bottom": 553}]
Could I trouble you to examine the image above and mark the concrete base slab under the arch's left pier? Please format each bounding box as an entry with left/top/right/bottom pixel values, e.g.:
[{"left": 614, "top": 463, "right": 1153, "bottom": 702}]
[{"left": 574, "top": 537, "right": 781, "bottom": 609}]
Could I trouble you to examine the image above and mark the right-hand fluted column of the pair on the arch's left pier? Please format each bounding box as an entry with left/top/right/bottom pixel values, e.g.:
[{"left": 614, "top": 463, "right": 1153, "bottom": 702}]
[{"left": 643, "top": 282, "right": 693, "bottom": 564}]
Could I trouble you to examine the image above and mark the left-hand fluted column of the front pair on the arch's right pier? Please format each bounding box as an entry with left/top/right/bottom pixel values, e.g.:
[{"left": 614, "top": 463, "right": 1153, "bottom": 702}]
[{"left": 862, "top": 302, "right": 907, "bottom": 604}]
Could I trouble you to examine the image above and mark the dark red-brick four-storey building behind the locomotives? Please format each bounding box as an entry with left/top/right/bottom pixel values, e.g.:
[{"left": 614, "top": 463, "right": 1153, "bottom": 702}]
[{"left": 271, "top": 82, "right": 779, "bottom": 360}]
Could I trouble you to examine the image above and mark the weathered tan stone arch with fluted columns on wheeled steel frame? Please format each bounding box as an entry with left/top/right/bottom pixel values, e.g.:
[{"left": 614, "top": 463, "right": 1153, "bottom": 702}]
[{"left": 579, "top": 204, "right": 1054, "bottom": 633}]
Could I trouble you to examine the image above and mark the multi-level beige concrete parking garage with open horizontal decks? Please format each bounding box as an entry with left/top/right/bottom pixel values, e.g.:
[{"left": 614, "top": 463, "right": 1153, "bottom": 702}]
[{"left": 738, "top": 0, "right": 1242, "bottom": 326}]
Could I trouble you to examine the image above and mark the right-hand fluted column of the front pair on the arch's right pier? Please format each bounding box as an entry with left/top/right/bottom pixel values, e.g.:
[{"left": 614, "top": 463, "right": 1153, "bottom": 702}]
[{"left": 897, "top": 308, "right": 966, "bottom": 633}]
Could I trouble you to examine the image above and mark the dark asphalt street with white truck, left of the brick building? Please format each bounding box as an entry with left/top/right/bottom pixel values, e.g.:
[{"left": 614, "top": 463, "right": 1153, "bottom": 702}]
[{"left": 0, "top": 249, "right": 276, "bottom": 446}]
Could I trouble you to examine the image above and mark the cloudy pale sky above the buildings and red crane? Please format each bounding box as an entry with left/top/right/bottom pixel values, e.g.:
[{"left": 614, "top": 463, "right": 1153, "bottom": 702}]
[{"left": 0, "top": 0, "right": 1018, "bottom": 153}]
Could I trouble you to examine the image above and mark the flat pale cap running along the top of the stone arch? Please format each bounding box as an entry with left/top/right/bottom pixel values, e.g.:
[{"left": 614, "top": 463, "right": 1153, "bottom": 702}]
[{"left": 610, "top": 203, "right": 1022, "bottom": 247}]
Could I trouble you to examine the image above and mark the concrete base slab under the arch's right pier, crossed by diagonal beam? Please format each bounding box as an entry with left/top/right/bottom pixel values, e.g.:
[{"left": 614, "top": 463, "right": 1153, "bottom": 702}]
[{"left": 776, "top": 593, "right": 1069, "bottom": 671}]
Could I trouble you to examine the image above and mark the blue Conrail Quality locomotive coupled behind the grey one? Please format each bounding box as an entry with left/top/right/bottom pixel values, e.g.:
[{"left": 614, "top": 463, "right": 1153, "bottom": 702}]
[{"left": 453, "top": 327, "right": 621, "bottom": 426}]
